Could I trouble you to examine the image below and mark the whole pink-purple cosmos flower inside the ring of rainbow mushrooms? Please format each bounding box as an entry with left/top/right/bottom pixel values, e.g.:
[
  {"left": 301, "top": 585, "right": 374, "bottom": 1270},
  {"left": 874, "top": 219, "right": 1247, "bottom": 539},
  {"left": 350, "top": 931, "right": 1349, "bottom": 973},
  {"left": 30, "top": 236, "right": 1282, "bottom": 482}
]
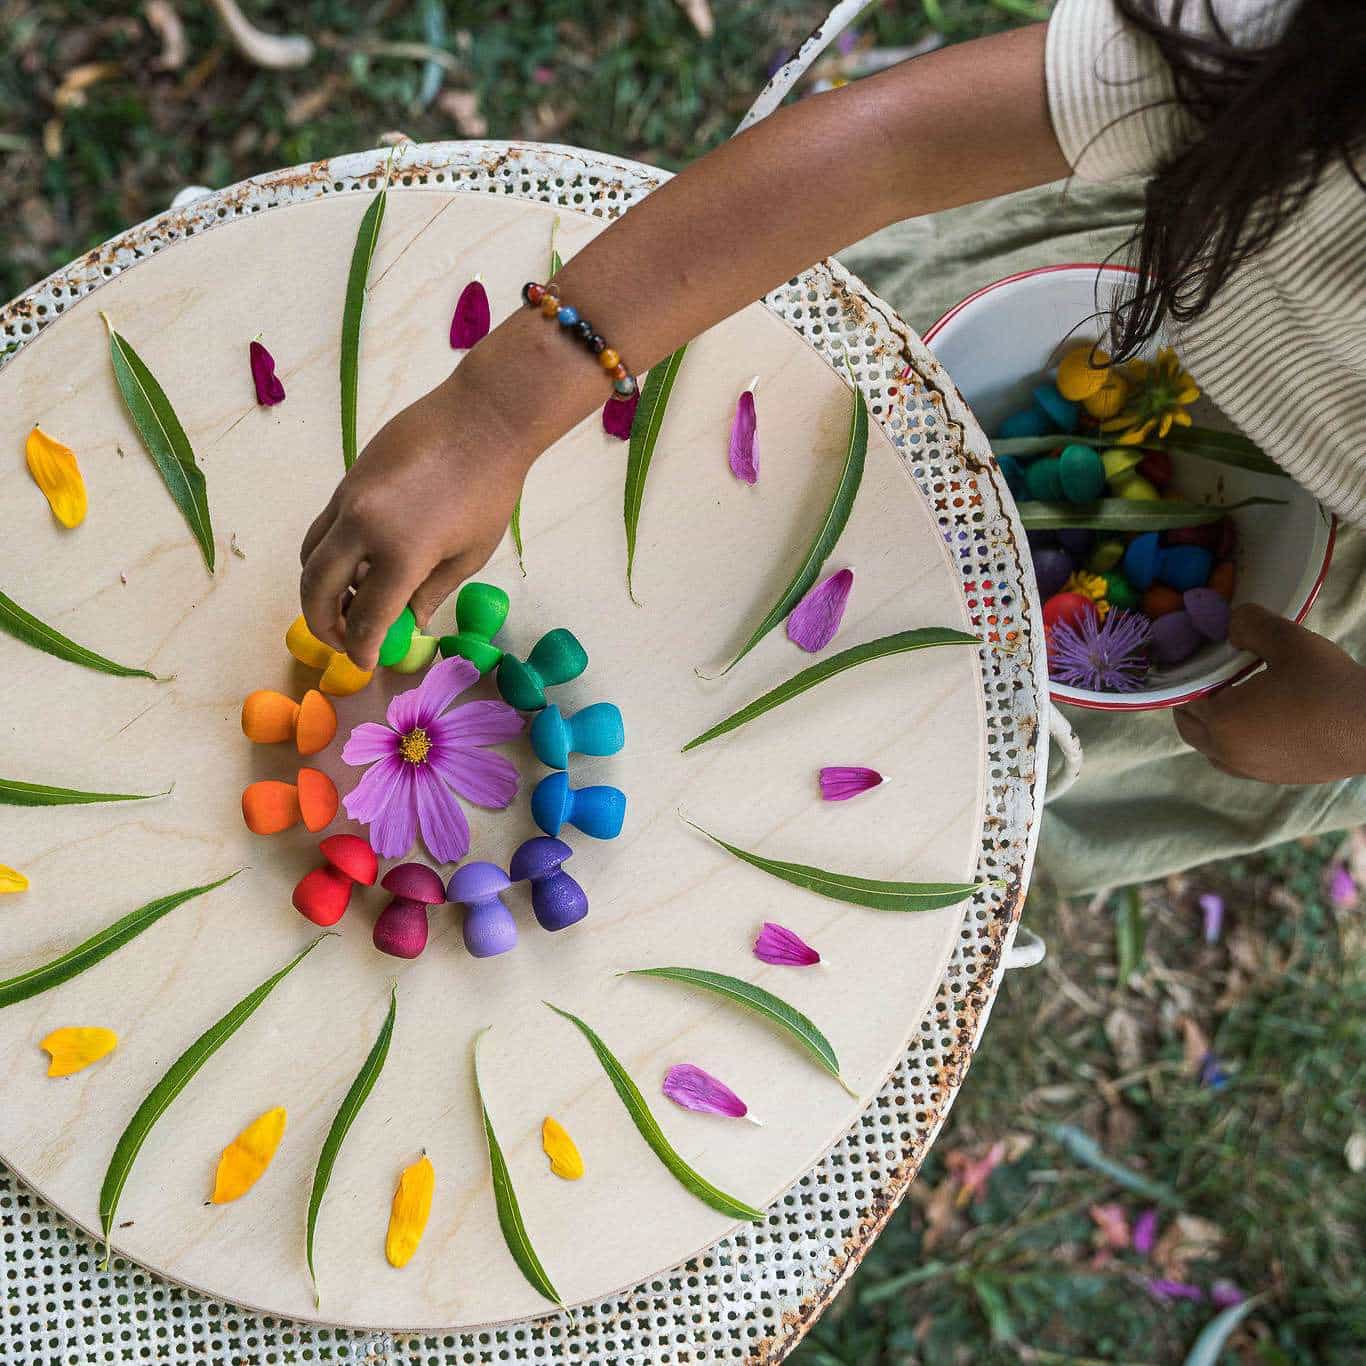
[{"left": 342, "top": 656, "right": 522, "bottom": 863}]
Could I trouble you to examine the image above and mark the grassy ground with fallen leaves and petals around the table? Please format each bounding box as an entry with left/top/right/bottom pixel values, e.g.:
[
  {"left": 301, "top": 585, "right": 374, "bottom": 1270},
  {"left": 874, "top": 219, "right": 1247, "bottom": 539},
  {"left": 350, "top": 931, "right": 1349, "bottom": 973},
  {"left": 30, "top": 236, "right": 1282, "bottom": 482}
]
[{"left": 0, "top": 0, "right": 1366, "bottom": 1366}]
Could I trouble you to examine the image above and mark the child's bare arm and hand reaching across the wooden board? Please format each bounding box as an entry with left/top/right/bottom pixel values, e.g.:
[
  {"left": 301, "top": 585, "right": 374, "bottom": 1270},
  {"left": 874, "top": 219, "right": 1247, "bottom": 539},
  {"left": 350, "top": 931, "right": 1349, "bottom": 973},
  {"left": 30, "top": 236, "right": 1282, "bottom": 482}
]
[{"left": 301, "top": 25, "right": 1068, "bottom": 668}]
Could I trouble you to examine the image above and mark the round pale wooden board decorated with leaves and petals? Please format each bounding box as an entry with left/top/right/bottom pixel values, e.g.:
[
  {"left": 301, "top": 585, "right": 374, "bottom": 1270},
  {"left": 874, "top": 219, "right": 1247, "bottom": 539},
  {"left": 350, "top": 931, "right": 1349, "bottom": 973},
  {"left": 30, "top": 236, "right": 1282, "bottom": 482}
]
[{"left": 0, "top": 176, "right": 988, "bottom": 1329}]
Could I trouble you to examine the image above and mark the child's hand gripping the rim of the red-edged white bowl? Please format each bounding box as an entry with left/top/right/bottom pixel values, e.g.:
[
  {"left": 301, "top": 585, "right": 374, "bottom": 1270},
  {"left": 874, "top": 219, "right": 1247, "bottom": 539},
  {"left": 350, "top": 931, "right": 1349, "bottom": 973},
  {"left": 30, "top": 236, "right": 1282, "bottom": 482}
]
[{"left": 1176, "top": 602, "right": 1366, "bottom": 783}]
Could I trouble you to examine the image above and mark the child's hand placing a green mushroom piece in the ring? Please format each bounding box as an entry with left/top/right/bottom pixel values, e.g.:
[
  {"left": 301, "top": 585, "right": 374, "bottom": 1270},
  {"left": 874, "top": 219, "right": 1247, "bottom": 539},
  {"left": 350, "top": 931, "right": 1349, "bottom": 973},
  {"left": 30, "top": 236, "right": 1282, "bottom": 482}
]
[{"left": 299, "top": 385, "right": 526, "bottom": 669}]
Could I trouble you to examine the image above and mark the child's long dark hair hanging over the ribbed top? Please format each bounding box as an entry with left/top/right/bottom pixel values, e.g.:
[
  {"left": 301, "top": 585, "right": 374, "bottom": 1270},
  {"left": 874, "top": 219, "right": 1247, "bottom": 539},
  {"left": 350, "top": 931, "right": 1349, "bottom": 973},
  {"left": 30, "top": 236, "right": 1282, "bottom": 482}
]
[{"left": 1111, "top": 0, "right": 1366, "bottom": 359}]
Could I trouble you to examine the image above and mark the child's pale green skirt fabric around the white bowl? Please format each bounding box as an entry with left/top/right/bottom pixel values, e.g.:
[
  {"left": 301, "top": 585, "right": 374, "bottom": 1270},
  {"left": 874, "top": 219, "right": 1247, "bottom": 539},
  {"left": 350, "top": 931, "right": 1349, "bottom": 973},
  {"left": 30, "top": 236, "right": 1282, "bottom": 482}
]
[{"left": 840, "top": 182, "right": 1366, "bottom": 895}]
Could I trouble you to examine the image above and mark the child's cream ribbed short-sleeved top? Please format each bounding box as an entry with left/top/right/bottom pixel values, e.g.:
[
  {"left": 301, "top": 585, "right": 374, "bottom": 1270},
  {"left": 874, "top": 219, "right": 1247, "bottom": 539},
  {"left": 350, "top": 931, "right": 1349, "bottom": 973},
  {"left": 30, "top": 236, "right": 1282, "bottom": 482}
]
[{"left": 1048, "top": 0, "right": 1366, "bottom": 526}]
